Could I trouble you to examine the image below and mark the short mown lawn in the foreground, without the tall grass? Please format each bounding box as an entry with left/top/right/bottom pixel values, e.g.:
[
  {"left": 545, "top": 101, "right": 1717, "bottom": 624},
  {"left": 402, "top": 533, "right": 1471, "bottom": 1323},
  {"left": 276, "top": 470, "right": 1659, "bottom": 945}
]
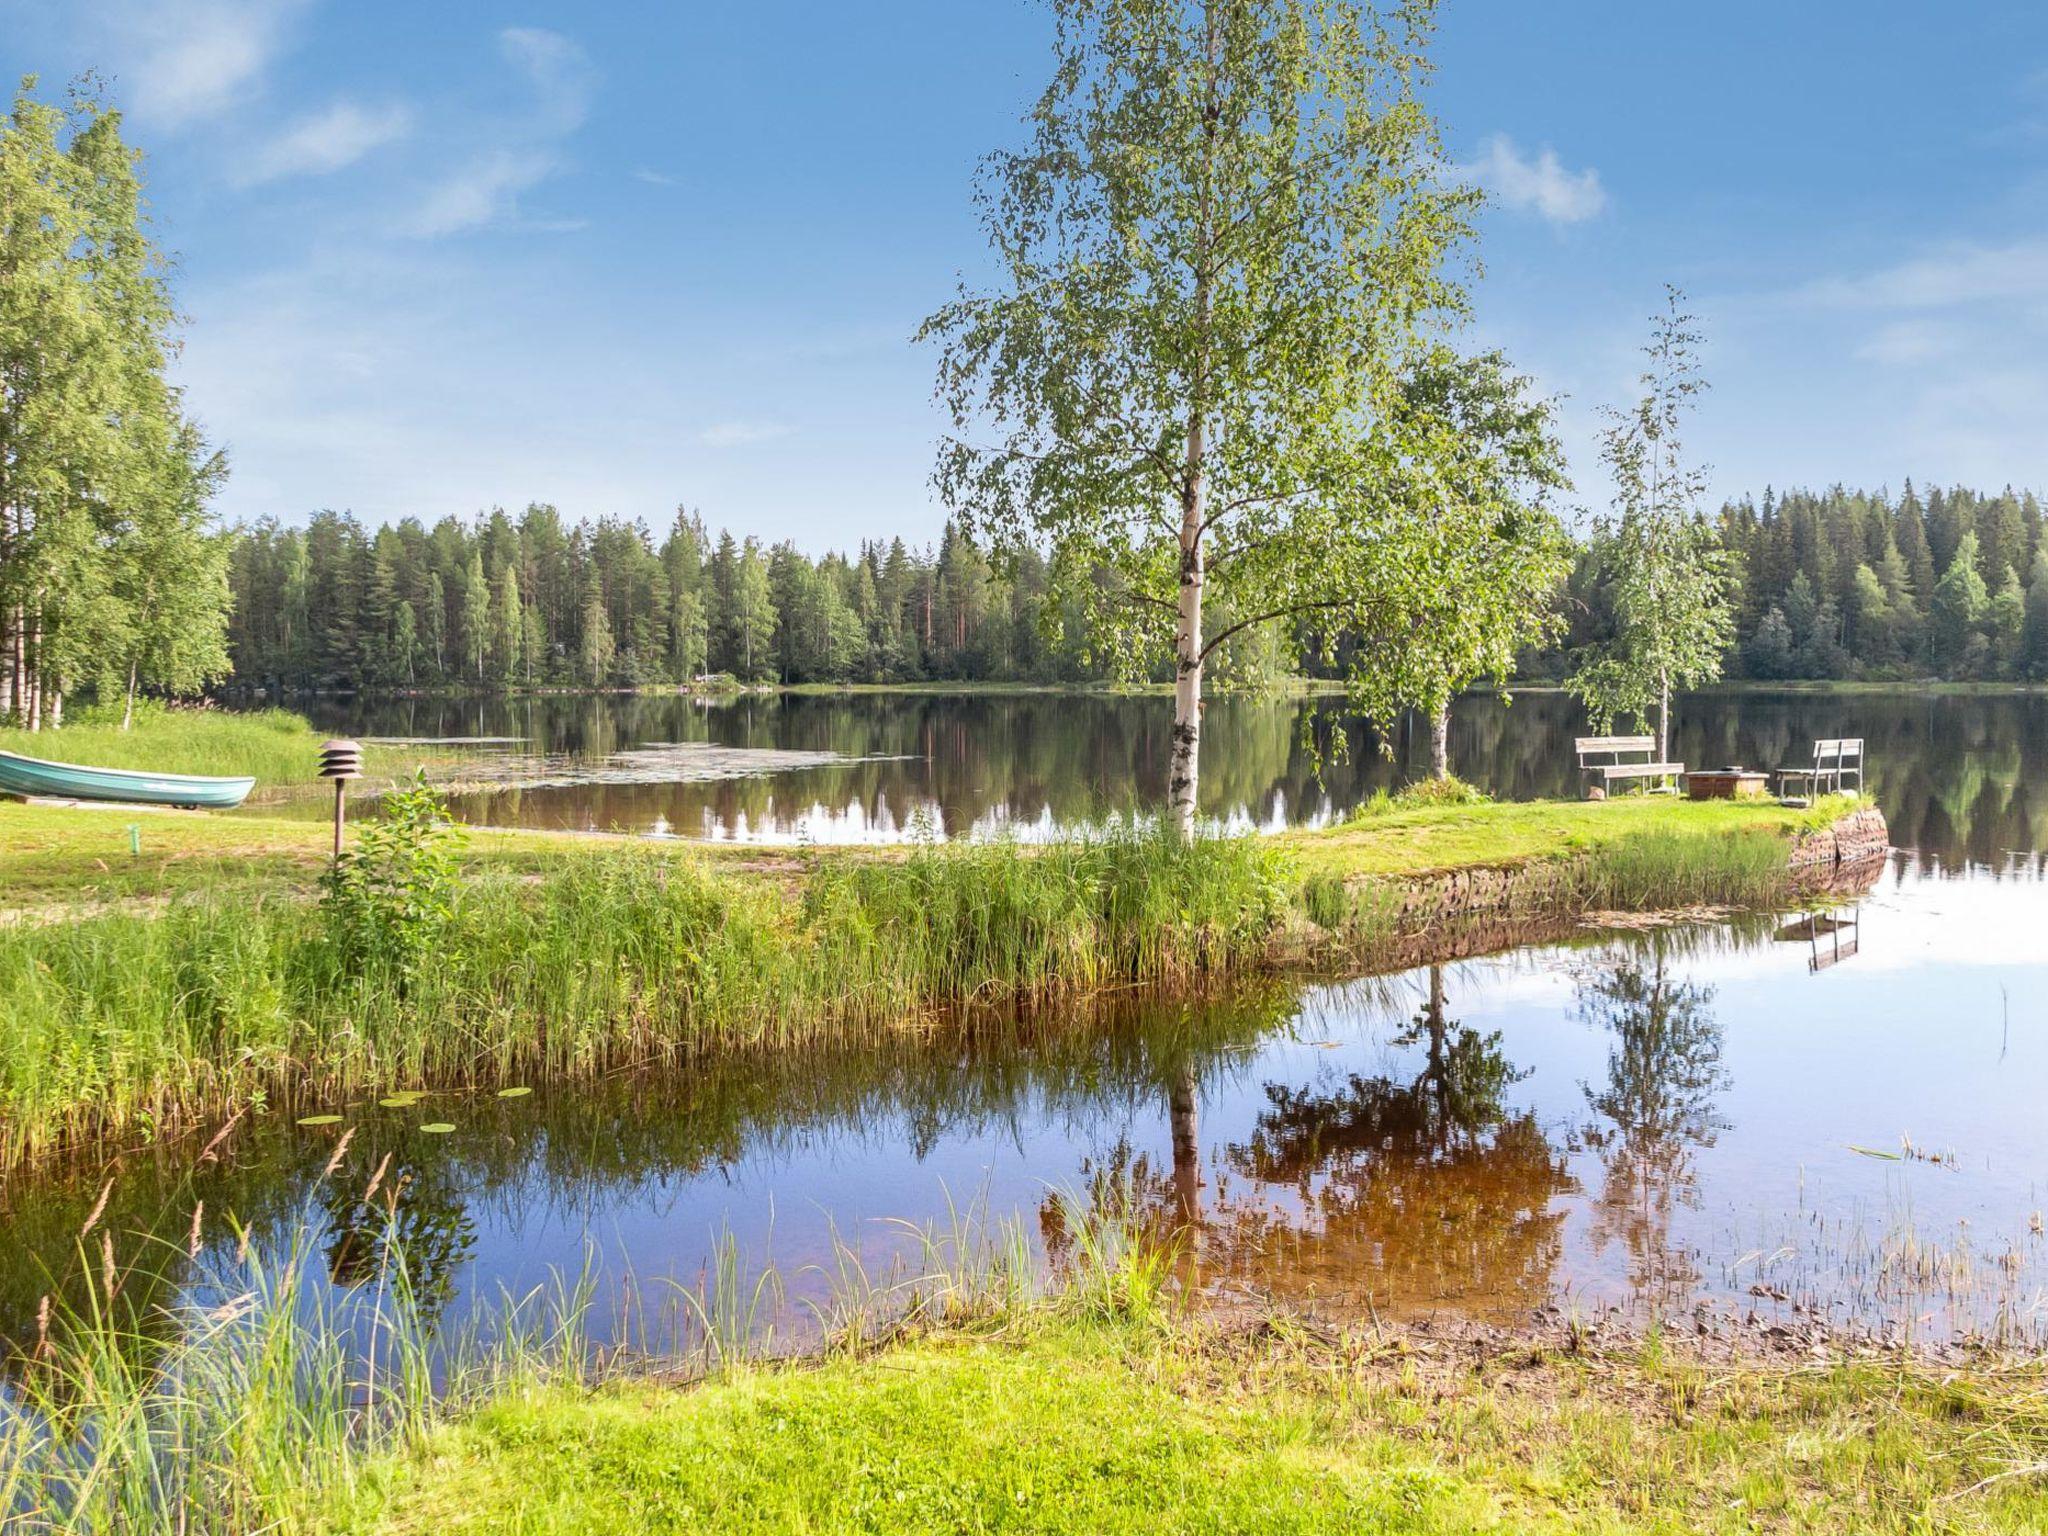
[{"left": 344, "top": 1319, "right": 2048, "bottom": 1536}]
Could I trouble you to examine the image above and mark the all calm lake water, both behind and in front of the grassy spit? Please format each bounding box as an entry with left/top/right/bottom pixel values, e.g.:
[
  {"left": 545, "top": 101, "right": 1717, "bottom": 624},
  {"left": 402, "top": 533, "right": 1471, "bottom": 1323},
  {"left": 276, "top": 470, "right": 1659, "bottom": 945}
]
[{"left": 0, "top": 694, "right": 2048, "bottom": 1341}]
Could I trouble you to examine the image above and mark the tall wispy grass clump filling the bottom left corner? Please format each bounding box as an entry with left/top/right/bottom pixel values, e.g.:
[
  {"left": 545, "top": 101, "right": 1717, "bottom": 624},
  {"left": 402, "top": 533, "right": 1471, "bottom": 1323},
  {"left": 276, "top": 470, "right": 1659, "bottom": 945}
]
[{"left": 0, "top": 1229, "right": 592, "bottom": 1536}]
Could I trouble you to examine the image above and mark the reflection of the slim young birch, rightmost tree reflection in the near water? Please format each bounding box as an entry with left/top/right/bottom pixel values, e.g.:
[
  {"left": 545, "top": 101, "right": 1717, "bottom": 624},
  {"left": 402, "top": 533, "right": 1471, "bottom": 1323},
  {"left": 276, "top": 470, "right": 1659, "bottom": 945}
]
[{"left": 1577, "top": 934, "right": 1729, "bottom": 1300}]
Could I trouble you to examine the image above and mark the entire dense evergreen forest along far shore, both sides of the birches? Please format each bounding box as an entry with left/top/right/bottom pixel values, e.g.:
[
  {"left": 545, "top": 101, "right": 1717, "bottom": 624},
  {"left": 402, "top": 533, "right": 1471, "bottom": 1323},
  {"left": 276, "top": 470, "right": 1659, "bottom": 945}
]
[{"left": 229, "top": 481, "right": 2048, "bottom": 688}]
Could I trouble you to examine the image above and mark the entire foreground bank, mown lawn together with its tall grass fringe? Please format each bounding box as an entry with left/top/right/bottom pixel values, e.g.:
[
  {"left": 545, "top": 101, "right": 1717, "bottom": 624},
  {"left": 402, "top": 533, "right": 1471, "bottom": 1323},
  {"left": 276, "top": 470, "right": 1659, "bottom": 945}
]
[{"left": 0, "top": 1196, "right": 2048, "bottom": 1536}]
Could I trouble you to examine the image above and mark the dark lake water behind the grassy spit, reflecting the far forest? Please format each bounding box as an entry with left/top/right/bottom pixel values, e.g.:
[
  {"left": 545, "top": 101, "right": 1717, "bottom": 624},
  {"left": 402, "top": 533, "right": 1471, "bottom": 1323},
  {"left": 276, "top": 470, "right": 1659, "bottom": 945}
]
[{"left": 307, "top": 688, "right": 2048, "bottom": 870}]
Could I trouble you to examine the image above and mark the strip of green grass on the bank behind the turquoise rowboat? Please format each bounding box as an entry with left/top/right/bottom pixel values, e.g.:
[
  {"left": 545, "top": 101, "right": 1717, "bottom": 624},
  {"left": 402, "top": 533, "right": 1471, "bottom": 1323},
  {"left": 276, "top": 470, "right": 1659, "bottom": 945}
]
[{"left": 0, "top": 702, "right": 432, "bottom": 786}]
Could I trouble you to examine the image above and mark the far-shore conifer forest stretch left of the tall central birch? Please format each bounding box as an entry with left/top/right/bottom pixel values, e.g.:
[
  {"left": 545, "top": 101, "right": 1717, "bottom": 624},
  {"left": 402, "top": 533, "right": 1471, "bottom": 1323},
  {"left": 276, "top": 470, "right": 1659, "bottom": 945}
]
[{"left": 229, "top": 504, "right": 1130, "bottom": 688}]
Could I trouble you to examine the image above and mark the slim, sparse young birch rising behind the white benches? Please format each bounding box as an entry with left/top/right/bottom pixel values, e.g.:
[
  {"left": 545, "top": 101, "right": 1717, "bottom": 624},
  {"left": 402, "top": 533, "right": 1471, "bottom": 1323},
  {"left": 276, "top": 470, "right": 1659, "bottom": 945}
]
[{"left": 1567, "top": 289, "right": 1735, "bottom": 762}]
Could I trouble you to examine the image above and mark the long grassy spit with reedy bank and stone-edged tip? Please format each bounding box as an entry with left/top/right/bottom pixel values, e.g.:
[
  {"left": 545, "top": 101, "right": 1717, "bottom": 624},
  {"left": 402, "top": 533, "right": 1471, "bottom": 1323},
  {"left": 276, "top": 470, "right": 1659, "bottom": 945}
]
[{"left": 0, "top": 797, "right": 1882, "bottom": 1167}]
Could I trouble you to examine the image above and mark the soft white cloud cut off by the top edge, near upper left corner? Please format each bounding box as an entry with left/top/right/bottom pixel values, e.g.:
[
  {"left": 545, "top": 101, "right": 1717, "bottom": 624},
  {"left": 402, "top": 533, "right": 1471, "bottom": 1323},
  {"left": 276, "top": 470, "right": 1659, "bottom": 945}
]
[{"left": 106, "top": 0, "right": 303, "bottom": 127}]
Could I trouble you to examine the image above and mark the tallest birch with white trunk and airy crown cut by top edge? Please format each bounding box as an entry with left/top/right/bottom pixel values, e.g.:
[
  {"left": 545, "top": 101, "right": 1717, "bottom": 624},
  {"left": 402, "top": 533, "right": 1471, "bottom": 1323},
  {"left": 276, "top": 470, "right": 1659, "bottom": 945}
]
[{"left": 920, "top": 0, "right": 1475, "bottom": 836}]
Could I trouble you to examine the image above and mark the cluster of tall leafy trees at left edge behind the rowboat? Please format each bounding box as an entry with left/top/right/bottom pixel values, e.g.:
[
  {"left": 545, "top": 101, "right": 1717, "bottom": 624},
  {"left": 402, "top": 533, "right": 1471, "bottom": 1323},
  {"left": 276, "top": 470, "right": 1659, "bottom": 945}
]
[{"left": 0, "top": 76, "right": 229, "bottom": 727}]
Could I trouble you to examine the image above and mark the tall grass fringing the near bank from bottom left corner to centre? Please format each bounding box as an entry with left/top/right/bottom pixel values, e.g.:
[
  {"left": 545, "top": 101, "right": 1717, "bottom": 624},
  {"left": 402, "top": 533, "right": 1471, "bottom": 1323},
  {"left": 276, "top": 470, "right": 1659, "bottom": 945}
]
[{"left": 0, "top": 1180, "right": 1165, "bottom": 1536}]
